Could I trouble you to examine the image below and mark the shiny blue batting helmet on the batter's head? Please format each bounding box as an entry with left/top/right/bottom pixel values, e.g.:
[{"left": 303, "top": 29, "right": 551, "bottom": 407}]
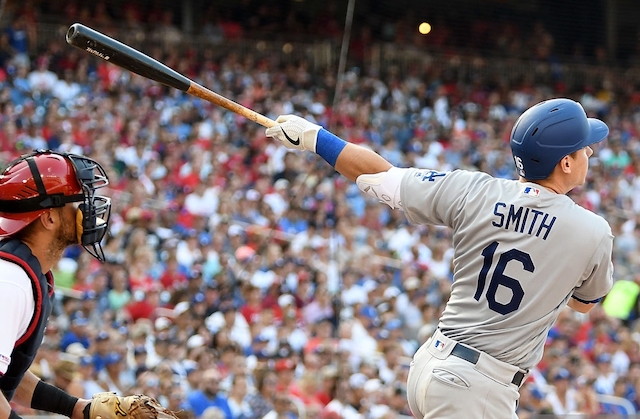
[{"left": 509, "top": 99, "right": 609, "bottom": 180}]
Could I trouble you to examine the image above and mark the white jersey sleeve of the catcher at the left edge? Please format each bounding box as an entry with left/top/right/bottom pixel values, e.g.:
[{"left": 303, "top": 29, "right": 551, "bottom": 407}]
[{"left": 0, "top": 262, "right": 35, "bottom": 374}]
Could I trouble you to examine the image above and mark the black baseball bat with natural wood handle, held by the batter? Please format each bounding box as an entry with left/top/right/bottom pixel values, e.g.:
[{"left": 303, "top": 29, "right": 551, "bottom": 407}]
[{"left": 66, "top": 23, "right": 275, "bottom": 128}]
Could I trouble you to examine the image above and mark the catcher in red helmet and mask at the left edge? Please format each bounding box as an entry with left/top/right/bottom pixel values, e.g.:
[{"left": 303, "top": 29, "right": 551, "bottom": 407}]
[{"left": 0, "top": 150, "right": 175, "bottom": 419}]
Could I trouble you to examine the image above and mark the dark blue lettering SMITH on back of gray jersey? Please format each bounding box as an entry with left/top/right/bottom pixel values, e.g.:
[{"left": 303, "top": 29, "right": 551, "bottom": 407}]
[{"left": 491, "top": 202, "right": 556, "bottom": 240}]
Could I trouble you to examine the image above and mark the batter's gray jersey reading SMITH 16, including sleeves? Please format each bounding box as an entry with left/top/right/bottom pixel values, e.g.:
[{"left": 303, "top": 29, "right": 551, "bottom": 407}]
[{"left": 400, "top": 169, "right": 613, "bottom": 369}]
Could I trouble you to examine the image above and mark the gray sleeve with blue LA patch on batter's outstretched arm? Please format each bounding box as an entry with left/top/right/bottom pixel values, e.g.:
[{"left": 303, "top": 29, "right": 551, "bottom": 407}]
[{"left": 400, "top": 169, "right": 489, "bottom": 228}]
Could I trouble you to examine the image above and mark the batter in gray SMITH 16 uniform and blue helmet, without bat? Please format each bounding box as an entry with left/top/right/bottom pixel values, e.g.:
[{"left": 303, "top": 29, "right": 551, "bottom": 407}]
[{"left": 266, "top": 99, "right": 613, "bottom": 419}]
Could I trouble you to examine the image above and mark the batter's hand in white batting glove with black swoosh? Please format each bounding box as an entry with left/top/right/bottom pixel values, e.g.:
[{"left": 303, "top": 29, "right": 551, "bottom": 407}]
[{"left": 265, "top": 115, "right": 322, "bottom": 153}]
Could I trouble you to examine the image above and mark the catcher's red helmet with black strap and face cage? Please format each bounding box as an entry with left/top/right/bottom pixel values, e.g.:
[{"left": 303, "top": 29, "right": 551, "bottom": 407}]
[{"left": 0, "top": 150, "right": 111, "bottom": 261}]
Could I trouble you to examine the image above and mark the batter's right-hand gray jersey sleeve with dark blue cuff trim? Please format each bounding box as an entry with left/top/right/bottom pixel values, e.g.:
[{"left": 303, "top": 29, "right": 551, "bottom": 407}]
[{"left": 573, "top": 225, "right": 613, "bottom": 303}]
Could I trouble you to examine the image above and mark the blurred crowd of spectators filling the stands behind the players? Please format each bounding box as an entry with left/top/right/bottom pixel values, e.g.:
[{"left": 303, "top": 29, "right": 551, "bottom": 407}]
[{"left": 0, "top": 3, "right": 640, "bottom": 419}]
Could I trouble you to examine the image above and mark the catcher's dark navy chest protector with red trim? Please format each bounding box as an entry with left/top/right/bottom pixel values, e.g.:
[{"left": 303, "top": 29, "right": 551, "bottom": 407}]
[{"left": 0, "top": 239, "right": 53, "bottom": 400}]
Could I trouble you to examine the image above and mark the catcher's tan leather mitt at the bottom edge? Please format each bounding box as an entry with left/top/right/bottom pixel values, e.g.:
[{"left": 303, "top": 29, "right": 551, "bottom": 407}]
[{"left": 89, "top": 392, "right": 178, "bottom": 419}]
